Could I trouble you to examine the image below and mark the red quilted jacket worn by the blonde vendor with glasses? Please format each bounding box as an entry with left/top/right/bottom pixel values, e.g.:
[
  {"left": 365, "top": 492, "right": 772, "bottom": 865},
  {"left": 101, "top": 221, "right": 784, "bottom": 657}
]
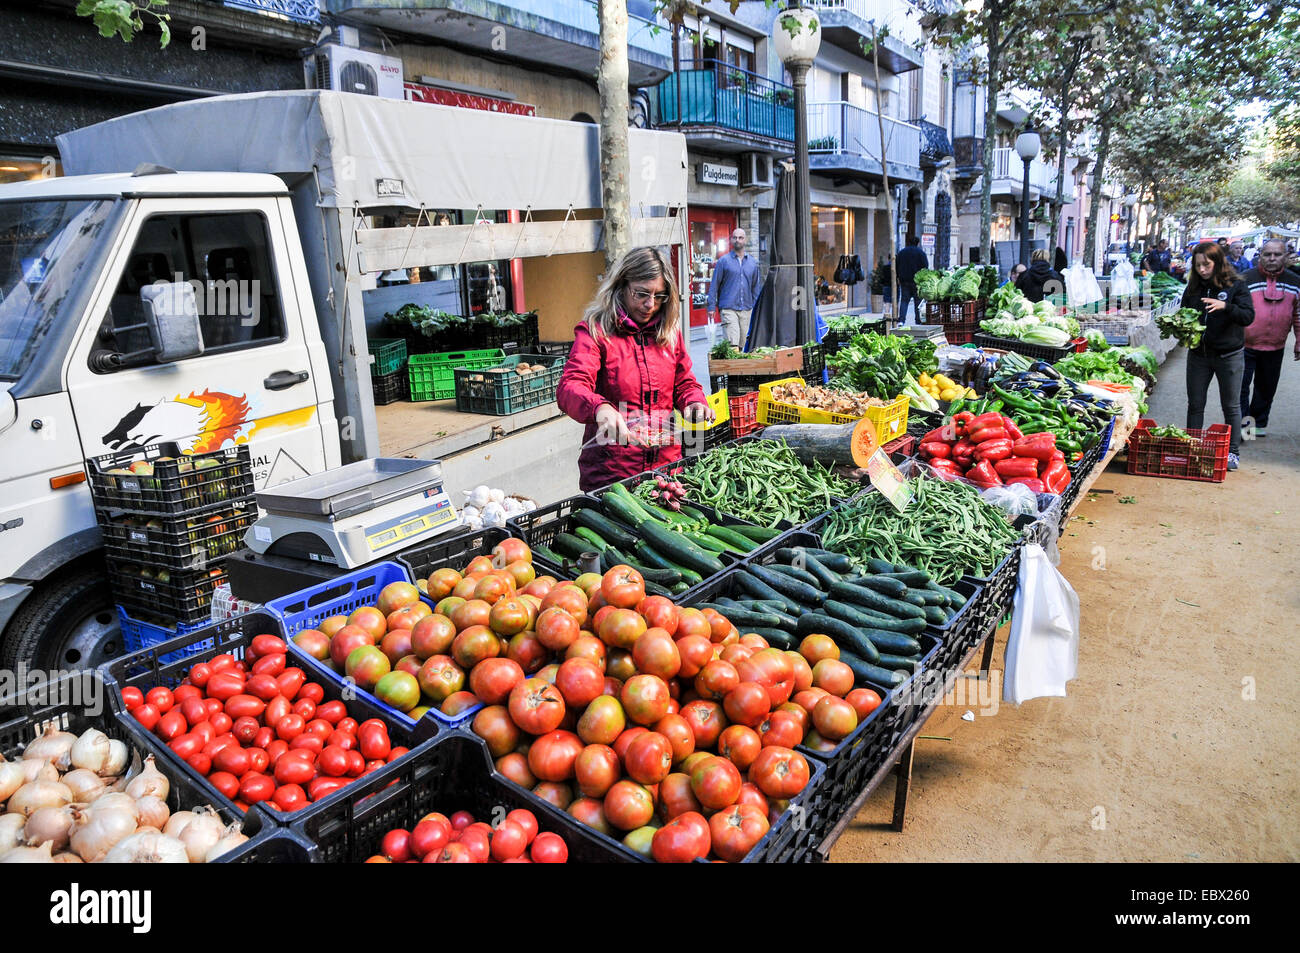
[{"left": 555, "top": 319, "right": 705, "bottom": 493}]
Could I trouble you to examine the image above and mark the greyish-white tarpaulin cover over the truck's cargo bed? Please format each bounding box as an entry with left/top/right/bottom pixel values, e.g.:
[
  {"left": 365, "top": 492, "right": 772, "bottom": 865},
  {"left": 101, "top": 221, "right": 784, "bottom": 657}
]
[{"left": 57, "top": 90, "right": 686, "bottom": 216}]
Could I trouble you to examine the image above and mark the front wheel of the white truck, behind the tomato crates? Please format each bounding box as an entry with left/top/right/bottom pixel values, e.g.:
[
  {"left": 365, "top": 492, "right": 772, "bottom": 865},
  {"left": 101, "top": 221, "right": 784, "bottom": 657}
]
[{"left": 0, "top": 566, "right": 125, "bottom": 671}]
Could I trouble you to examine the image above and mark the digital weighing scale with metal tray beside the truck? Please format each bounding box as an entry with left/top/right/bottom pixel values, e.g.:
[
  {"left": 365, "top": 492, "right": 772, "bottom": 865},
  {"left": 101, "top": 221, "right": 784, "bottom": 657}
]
[{"left": 244, "top": 458, "right": 460, "bottom": 569}]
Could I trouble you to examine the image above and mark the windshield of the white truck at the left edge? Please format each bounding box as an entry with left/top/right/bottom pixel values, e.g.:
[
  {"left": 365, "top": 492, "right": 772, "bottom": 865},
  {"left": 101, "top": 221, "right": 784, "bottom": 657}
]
[{"left": 0, "top": 199, "right": 113, "bottom": 381}]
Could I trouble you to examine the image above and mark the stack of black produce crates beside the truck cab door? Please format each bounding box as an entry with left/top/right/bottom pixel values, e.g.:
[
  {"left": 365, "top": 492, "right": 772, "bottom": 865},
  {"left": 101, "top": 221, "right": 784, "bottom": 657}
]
[{"left": 86, "top": 443, "right": 257, "bottom": 651}]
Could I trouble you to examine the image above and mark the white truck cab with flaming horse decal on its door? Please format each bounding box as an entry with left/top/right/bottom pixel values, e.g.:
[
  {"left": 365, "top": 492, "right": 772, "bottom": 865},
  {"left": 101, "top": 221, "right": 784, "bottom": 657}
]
[{"left": 0, "top": 166, "right": 341, "bottom": 670}]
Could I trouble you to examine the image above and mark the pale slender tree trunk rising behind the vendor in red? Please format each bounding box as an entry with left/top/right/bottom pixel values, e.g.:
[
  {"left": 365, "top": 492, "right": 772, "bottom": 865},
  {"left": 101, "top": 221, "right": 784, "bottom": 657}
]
[{"left": 597, "top": 0, "right": 632, "bottom": 272}]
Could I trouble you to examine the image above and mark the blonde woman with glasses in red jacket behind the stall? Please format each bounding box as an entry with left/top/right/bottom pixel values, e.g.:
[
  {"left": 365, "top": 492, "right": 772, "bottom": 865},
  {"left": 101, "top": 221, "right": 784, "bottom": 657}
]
[{"left": 555, "top": 248, "right": 714, "bottom": 491}]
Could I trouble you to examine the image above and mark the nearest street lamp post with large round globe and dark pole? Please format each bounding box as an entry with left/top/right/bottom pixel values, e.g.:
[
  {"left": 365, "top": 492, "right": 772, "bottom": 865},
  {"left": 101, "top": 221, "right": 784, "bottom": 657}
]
[{"left": 772, "top": 7, "right": 822, "bottom": 343}]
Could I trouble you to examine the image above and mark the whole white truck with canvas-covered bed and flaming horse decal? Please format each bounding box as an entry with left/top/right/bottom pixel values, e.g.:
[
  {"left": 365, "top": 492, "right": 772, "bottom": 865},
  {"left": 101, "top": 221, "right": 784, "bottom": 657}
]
[{"left": 0, "top": 91, "right": 686, "bottom": 670}]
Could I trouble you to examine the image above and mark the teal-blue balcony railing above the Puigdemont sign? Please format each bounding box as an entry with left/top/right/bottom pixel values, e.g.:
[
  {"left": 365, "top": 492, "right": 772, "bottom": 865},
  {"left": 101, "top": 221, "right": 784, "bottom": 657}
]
[{"left": 658, "top": 60, "right": 794, "bottom": 142}]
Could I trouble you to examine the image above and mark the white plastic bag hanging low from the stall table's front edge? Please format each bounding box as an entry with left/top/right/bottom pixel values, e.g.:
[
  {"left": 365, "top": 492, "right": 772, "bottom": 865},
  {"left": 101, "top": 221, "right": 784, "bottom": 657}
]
[{"left": 1002, "top": 543, "right": 1079, "bottom": 705}]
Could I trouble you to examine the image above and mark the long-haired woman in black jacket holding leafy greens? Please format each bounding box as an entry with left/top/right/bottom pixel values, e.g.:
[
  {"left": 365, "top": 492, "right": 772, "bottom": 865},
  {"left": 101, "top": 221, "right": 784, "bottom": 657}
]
[{"left": 1182, "top": 242, "right": 1255, "bottom": 469}]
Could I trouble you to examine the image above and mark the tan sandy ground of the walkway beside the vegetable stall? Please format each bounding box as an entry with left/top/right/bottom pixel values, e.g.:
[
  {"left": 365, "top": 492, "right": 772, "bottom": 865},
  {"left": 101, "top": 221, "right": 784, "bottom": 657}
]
[{"left": 831, "top": 348, "right": 1300, "bottom": 863}]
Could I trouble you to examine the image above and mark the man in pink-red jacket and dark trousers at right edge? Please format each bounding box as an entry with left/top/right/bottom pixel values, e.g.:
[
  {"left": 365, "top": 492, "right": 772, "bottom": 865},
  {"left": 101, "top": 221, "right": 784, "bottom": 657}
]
[{"left": 1242, "top": 238, "right": 1300, "bottom": 437}]
